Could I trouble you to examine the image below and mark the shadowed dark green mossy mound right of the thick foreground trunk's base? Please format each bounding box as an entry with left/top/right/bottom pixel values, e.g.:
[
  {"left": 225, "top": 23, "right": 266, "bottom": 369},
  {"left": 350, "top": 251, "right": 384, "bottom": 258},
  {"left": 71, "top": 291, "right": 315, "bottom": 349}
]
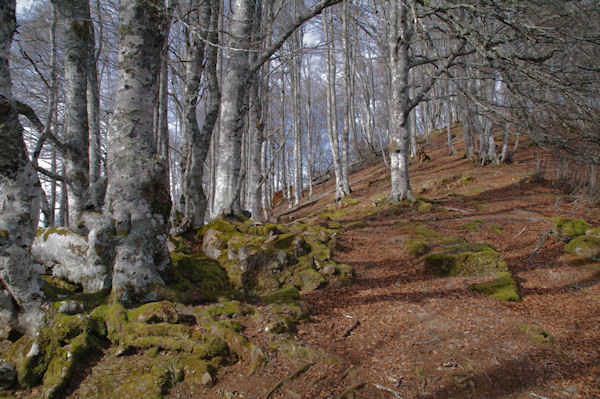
[{"left": 163, "top": 252, "right": 232, "bottom": 303}]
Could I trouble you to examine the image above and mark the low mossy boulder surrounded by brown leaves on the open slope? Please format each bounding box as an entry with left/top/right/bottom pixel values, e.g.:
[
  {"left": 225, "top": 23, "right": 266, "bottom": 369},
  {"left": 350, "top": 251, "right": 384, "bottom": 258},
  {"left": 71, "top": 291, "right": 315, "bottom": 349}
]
[{"left": 425, "top": 244, "right": 507, "bottom": 276}]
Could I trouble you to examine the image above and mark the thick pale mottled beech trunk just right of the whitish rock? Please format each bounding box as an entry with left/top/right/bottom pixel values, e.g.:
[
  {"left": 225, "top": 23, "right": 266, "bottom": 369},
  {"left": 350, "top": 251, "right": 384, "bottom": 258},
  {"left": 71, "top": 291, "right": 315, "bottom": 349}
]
[{"left": 105, "top": 0, "right": 171, "bottom": 303}]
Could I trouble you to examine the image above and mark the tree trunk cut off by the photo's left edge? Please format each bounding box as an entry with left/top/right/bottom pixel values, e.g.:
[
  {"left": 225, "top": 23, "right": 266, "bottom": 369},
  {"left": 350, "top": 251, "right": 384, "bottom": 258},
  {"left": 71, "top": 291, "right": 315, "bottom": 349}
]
[{"left": 0, "top": 0, "right": 44, "bottom": 338}]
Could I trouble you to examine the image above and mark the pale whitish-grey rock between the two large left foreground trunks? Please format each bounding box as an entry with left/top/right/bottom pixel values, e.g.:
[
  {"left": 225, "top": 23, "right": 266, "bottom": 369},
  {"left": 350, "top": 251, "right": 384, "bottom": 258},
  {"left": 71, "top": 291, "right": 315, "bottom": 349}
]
[{"left": 31, "top": 227, "right": 111, "bottom": 292}]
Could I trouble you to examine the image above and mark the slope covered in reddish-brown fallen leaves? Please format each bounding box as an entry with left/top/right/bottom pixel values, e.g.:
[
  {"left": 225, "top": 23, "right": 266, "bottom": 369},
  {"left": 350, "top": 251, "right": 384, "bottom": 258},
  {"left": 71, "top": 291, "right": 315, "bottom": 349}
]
[{"left": 197, "top": 131, "right": 600, "bottom": 399}]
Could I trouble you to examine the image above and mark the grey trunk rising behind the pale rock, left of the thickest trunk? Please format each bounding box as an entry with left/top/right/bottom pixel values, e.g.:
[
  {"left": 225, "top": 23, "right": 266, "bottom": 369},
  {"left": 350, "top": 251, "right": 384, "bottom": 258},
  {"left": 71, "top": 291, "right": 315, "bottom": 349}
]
[{"left": 52, "top": 0, "right": 91, "bottom": 231}]
